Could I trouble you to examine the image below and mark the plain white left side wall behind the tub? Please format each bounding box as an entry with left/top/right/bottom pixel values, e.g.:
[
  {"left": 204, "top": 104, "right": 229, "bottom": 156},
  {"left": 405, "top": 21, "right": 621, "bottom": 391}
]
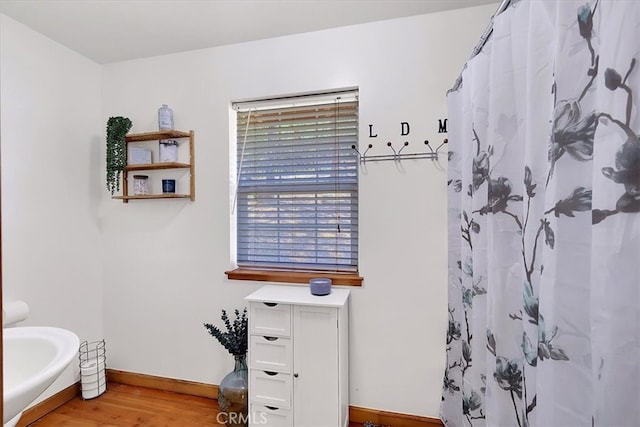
[{"left": 0, "top": 15, "right": 104, "bottom": 404}]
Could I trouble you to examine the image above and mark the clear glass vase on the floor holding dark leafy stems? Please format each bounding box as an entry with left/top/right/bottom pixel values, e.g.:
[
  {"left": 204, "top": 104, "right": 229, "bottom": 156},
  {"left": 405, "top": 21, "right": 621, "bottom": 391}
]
[{"left": 218, "top": 354, "right": 249, "bottom": 427}]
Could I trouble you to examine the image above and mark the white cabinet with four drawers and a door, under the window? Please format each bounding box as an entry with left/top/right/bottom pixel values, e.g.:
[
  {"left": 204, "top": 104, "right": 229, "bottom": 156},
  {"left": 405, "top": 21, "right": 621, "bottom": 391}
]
[{"left": 246, "top": 285, "right": 349, "bottom": 427}]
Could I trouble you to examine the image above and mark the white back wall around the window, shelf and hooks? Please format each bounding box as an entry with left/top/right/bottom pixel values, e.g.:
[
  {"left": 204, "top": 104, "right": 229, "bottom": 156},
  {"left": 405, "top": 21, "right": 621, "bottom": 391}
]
[{"left": 96, "top": 5, "right": 495, "bottom": 416}]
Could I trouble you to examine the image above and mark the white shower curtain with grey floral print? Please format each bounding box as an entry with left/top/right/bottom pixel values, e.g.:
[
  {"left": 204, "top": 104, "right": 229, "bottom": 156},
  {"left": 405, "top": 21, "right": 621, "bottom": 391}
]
[{"left": 440, "top": 0, "right": 640, "bottom": 427}]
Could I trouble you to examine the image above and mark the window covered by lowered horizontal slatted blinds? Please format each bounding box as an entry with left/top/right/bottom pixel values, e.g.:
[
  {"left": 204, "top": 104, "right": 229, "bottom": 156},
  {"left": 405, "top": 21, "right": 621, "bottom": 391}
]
[{"left": 234, "top": 91, "right": 358, "bottom": 272}]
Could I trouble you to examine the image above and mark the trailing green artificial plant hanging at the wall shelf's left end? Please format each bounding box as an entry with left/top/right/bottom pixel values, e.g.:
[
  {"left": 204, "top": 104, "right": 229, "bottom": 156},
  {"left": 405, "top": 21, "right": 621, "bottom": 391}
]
[{"left": 107, "top": 116, "right": 133, "bottom": 195}]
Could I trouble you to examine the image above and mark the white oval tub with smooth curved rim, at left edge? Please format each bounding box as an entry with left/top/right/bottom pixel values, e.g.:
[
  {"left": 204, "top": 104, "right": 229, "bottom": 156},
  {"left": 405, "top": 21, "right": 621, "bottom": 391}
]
[{"left": 2, "top": 326, "right": 80, "bottom": 425}]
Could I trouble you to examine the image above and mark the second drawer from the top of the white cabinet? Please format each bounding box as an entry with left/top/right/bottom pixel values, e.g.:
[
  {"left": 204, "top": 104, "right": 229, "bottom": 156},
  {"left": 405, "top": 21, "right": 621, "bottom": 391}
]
[{"left": 249, "top": 335, "right": 292, "bottom": 372}]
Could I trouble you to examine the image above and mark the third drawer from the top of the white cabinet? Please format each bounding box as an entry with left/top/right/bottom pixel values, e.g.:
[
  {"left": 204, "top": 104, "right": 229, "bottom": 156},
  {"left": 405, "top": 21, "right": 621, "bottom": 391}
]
[{"left": 249, "top": 369, "right": 291, "bottom": 408}]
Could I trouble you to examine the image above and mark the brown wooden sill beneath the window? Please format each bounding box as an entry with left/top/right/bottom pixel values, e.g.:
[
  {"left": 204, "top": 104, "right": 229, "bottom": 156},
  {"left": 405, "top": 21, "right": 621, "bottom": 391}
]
[{"left": 225, "top": 268, "right": 364, "bottom": 286}]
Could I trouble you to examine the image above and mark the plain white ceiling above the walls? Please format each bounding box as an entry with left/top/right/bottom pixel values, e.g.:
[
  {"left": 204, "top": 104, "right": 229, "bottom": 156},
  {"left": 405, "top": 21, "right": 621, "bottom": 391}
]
[{"left": 0, "top": 0, "right": 499, "bottom": 64}]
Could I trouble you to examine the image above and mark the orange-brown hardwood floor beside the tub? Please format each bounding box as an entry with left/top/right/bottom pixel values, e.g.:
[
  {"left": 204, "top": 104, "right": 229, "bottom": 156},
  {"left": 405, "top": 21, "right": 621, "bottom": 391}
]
[{"left": 30, "top": 383, "right": 362, "bottom": 427}]
